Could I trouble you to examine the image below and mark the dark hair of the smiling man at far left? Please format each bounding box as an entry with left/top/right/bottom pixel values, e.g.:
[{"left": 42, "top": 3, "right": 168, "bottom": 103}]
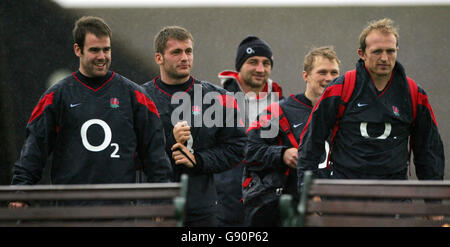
[{"left": 72, "top": 16, "right": 112, "bottom": 52}]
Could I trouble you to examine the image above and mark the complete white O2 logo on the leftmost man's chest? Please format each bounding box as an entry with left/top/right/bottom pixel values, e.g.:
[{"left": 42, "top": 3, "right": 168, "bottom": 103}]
[{"left": 81, "top": 119, "right": 120, "bottom": 158}]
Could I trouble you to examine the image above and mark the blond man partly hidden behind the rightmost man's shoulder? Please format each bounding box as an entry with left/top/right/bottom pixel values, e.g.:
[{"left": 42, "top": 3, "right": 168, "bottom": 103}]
[{"left": 243, "top": 47, "right": 340, "bottom": 226}]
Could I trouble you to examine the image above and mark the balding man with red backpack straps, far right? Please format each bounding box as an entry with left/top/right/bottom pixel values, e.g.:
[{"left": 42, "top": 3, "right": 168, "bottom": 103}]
[{"left": 297, "top": 19, "right": 444, "bottom": 188}]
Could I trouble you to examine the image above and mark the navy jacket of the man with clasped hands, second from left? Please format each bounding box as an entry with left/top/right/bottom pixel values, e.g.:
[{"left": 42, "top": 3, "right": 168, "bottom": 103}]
[{"left": 143, "top": 77, "right": 246, "bottom": 221}]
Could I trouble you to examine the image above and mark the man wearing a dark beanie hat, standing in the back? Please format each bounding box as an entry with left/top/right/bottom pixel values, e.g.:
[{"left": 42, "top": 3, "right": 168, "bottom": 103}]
[{"left": 214, "top": 36, "right": 282, "bottom": 226}]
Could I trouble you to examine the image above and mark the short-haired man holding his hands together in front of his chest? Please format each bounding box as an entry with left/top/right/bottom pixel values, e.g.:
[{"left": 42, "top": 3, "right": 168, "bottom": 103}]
[{"left": 143, "top": 26, "right": 246, "bottom": 226}]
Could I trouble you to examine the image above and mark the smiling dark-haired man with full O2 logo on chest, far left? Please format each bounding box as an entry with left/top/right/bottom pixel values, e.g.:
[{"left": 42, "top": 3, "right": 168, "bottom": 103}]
[{"left": 10, "top": 17, "right": 172, "bottom": 207}]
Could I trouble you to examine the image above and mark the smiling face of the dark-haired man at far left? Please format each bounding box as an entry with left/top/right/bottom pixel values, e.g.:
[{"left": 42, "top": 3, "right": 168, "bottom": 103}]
[{"left": 74, "top": 33, "right": 111, "bottom": 78}]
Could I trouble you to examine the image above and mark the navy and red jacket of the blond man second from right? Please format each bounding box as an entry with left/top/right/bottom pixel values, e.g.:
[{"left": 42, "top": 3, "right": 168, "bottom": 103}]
[{"left": 243, "top": 94, "right": 327, "bottom": 207}]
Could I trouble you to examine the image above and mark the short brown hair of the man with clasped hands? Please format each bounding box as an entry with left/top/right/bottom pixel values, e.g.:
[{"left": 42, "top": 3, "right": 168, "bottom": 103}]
[{"left": 154, "top": 26, "right": 194, "bottom": 54}]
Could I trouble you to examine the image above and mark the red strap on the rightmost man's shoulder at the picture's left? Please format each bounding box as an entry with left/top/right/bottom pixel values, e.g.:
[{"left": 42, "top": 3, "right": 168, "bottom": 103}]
[{"left": 327, "top": 69, "right": 356, "bottom": 168}]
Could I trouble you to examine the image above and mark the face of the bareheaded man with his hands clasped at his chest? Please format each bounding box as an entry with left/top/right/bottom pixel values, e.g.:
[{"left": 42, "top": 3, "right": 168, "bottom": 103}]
[{"left": 155, "top": 39, "right": 194, "bottom": 84}]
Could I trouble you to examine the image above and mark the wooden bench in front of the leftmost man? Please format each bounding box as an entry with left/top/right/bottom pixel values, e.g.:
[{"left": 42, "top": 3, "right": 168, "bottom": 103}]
[{"left": 0, "top": 175, "right": 188, "bottom": 227}]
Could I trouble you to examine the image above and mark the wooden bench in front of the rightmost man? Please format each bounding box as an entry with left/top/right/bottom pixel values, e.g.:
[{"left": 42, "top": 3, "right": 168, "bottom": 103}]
[{"left": 280, "top": 171, "right": 450, "bottom": 227}]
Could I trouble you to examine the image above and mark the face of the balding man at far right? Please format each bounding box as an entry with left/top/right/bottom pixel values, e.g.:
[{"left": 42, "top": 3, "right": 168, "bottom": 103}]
[{"left": 358, "top": 30, "right": 398, "bottom": 79}]
